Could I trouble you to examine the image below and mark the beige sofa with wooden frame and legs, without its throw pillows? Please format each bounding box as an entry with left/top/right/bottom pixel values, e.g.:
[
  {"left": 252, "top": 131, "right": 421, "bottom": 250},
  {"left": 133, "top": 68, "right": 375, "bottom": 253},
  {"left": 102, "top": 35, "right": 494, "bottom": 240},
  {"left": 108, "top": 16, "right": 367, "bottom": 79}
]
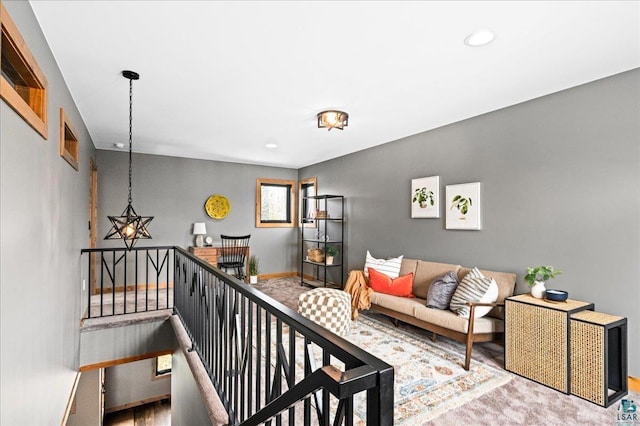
[{"left": 370, "top": 259, "right": 516, "bottom": 370}]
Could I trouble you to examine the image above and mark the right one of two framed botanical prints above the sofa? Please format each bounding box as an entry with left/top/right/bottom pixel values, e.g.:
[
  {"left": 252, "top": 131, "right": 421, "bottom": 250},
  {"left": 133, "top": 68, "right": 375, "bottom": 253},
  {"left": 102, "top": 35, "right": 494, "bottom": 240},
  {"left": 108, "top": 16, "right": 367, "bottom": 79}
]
[{"left": 446, "top": 182, "right": 481, "bottom": 230}]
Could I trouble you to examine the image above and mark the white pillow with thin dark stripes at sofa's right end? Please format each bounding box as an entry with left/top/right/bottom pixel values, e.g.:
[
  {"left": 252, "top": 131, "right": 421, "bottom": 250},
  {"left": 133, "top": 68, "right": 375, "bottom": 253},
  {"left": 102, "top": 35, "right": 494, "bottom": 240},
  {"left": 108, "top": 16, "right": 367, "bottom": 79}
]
[{"left": 450, "top": 268, "right": 498, "bottom": 318}]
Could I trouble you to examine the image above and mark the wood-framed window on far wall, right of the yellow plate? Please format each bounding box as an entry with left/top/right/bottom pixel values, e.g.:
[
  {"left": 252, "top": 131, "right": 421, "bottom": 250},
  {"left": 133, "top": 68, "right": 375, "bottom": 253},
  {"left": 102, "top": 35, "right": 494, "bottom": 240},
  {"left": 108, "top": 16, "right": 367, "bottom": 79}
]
[{"left": 256, "top": 178, "right": 296, "bottom": 228}]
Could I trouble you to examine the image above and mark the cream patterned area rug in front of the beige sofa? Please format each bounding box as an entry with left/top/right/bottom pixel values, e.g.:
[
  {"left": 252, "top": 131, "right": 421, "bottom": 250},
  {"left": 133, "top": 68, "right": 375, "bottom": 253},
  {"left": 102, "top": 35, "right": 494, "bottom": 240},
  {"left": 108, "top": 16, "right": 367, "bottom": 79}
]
[{"left": 338, "top": 316, "right": 512, "bottom": 425}]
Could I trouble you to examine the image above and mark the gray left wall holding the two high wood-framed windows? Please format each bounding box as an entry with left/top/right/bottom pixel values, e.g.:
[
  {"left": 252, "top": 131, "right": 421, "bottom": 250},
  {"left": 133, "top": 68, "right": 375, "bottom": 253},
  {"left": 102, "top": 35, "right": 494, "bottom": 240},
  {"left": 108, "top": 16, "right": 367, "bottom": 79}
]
[{"left": 0, "top": 1, "right": 95, "bottom": 425}]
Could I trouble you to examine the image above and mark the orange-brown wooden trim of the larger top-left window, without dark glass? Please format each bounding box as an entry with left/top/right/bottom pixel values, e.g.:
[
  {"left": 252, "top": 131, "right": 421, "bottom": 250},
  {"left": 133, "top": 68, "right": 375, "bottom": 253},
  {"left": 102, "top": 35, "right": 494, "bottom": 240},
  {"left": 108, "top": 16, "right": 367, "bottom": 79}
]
[{"left": 0, "top": 2, "right": 49, "bottom": 139}]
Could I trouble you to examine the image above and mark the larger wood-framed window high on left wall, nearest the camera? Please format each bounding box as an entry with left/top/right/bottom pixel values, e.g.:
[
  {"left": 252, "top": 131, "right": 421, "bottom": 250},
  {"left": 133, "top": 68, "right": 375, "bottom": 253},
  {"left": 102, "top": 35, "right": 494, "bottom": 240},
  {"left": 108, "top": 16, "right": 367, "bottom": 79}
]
[{"left": 0, "top": 2, "right": 49, "bottom": 139}]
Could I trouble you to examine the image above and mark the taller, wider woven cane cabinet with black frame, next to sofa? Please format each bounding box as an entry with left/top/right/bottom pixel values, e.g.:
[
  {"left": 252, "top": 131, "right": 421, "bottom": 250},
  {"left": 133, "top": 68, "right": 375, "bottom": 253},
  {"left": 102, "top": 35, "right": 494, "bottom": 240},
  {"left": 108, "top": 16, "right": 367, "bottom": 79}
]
[{"left": 504, "top": 294, "right": 594, "bottom": 394}]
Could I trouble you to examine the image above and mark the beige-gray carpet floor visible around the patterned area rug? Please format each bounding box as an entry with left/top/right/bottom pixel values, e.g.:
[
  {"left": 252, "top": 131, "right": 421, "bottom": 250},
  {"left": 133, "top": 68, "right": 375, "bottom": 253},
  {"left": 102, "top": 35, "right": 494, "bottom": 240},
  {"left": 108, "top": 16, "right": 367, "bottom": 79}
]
[{"left": 255, "top": 278, "right": 640, "bottom": 425}]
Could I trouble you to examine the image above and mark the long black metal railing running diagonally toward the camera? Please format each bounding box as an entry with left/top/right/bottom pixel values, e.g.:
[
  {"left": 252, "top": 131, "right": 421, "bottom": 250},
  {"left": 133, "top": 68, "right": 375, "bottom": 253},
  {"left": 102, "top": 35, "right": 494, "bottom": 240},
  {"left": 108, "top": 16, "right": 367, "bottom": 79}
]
[{"left": 174, "top": 247, "right": 394, "bottom": 426}]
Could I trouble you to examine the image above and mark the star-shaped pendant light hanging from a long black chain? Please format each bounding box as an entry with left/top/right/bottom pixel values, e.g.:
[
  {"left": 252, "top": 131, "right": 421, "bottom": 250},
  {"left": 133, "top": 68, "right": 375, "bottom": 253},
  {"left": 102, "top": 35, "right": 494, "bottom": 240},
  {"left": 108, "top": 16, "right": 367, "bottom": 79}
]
[{"left": 104, "top": 71, "right": 153, "bottom": 250}]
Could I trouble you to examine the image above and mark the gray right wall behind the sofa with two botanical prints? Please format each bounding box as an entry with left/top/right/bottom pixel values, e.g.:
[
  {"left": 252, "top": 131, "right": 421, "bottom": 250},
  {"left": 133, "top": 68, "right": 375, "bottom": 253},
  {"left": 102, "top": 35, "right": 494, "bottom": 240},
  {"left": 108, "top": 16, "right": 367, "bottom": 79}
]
[{"left": 300, "top": 69, "right": 640, "bottom": 377}]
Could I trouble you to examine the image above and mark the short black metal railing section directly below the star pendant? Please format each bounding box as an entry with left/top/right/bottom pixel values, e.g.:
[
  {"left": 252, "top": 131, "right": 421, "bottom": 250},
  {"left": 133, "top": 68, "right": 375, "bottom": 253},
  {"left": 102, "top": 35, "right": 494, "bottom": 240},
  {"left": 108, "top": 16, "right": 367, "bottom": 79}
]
[{"left": 81, "top": 247, "right": 175, "bottom": 318}]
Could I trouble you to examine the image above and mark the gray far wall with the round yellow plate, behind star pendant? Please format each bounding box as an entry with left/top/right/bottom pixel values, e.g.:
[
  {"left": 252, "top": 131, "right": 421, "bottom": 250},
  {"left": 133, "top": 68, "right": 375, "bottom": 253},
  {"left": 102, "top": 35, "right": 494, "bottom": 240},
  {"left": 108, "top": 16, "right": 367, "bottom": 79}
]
[{"left": 97, "top": 151, "right": 298, "bottom": 274}]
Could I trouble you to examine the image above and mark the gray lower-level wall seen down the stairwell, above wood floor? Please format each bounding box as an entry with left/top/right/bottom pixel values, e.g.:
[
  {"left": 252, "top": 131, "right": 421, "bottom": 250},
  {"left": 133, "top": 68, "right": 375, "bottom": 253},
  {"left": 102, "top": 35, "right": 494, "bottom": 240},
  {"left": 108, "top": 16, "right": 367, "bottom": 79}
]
[{"left": 104, "top": 358, "right": 173, "bottom": 411}]
